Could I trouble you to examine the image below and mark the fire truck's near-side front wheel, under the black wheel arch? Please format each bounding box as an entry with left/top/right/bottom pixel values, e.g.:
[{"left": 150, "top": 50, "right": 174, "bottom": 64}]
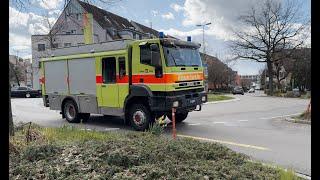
[{"left": 126, "top": 104, "right": 153, "bottom": 131}]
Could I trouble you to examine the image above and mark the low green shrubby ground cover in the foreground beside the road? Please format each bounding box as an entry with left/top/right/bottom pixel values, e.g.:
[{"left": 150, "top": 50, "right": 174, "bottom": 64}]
[{"left": 9, "top": 123, "right": 302, "bottom": 179}]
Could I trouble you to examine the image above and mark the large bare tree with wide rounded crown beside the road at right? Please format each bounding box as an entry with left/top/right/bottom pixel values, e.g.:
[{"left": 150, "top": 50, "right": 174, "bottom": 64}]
[{"left": 231, "top": 0, "right": 309, "bottom": 95}]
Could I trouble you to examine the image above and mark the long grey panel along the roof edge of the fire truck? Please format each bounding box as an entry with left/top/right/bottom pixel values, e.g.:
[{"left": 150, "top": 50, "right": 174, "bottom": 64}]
[{"left": 47, "top": 39, "right": 133, "bottom": 57}]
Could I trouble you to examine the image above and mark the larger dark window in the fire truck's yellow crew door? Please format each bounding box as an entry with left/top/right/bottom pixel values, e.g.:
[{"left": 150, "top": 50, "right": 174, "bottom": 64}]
[{"left": 102, "top": 57, "right": 116, "bottom": 84}]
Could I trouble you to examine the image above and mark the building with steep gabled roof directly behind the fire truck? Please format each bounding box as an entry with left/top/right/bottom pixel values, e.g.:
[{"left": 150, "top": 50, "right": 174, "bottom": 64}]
[{"left": 31, "top": 0, "right": 159, "bottom": 89}]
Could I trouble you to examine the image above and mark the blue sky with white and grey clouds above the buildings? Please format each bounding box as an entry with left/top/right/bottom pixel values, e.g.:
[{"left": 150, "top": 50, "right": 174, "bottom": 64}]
[{"left": 9, "top": 0, "right": 311, "bottom": 75}]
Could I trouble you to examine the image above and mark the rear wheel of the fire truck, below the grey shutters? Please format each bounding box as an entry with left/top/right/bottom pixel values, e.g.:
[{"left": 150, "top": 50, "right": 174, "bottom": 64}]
[{"left": 62, "top": 100, "right": 82, "bottom": 123}]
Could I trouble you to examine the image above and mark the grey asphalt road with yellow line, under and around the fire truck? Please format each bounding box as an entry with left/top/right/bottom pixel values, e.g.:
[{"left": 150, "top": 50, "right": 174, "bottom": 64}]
[{"left": 12, "top": 92, "right": 311, "bottom": 175}]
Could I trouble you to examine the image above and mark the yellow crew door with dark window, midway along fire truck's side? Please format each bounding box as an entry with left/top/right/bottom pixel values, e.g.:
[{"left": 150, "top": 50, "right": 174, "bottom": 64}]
[{"left": 101, "top": 57, "right": 119, "bottom": 107}]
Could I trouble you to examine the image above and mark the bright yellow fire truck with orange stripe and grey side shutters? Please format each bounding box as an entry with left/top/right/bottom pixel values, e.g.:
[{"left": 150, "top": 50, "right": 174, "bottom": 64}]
[{"left": 40, "top": 35, "right": 207, "bottom": 131}]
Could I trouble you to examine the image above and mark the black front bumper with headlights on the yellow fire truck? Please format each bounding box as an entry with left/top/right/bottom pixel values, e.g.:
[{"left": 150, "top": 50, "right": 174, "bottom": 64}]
[{"left": 150, "top": 92, "right": 208, "bottom": 112}]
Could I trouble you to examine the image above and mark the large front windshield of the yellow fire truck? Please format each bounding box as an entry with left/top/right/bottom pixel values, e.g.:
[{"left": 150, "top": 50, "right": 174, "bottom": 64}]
[{"left": 163, "top": 46, "right": 202, "bottom": 67}]
